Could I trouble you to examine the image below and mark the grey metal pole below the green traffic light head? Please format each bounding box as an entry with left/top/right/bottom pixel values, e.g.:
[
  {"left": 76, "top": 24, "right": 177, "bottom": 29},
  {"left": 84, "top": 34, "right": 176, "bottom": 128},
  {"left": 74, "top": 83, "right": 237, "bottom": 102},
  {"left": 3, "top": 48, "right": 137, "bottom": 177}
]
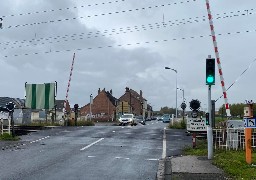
[{"left": 207, "top": 85, "right": 213, "bottom": 159}]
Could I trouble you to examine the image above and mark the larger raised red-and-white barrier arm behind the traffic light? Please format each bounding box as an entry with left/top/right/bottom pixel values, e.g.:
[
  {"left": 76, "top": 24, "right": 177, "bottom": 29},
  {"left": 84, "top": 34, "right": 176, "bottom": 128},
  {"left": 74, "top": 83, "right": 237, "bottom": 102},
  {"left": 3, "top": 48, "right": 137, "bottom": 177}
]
[{"left": 206, "top": 0, "right": 231, "bottom": 117}]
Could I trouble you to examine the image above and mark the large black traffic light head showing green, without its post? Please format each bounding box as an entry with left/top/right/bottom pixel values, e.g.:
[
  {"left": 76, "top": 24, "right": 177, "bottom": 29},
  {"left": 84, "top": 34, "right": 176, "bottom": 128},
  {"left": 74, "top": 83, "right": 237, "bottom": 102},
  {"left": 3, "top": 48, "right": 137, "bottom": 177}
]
[{"left": 206, "top": 58, "right": 215, "bottom": 85}]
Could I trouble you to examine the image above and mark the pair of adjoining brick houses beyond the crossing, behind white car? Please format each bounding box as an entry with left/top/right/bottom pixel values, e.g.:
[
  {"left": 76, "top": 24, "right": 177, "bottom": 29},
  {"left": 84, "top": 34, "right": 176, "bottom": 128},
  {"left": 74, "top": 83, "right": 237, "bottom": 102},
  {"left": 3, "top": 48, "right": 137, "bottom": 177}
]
[{"left": 80, "top": 87, "right": 153, "bottom": 121}]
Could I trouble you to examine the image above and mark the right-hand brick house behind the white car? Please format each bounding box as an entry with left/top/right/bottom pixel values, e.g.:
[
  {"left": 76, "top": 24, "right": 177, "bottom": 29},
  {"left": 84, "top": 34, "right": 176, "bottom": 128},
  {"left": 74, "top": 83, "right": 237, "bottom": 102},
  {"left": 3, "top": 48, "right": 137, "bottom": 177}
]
[{"left": 119, "top": 87, "right": 146, "bottom": 115}]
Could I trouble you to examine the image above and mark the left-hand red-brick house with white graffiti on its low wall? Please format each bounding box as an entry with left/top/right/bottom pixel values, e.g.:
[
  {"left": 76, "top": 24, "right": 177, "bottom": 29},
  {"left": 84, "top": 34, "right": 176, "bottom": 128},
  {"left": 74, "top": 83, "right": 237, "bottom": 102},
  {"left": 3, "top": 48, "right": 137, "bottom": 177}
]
[{"left": 80, "top": 88, "right": 118, "bottom": 121}]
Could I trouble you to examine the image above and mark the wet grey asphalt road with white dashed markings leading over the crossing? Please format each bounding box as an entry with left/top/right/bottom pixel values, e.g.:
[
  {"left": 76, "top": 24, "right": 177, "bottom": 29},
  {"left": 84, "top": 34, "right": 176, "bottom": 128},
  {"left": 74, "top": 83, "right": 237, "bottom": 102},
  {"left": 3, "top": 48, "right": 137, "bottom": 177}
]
[{"left": 0, "top": 121, "right": 190, "bottom": 180}]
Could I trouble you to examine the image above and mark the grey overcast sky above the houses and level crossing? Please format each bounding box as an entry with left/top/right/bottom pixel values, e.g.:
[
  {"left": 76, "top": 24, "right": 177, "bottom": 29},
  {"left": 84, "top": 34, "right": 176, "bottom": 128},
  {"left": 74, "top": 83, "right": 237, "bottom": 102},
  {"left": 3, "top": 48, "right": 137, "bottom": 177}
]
[{"left": 0, "top": 0, "right": 256, "bottom": 110}]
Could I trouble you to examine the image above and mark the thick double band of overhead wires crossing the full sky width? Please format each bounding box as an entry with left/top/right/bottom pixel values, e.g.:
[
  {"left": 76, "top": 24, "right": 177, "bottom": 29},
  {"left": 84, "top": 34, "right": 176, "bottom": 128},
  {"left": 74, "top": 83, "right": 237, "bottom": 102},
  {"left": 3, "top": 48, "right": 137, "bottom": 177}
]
[{"left": 0, "top": 9, "right": 255, "bottom": 50}]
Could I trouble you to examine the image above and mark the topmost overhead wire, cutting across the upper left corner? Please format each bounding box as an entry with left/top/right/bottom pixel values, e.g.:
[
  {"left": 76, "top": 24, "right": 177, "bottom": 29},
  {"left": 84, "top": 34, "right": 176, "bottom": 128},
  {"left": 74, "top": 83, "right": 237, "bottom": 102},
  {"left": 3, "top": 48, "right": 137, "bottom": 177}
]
[{"left": 2, "top": 0, "right": 125, "bottom": 18}]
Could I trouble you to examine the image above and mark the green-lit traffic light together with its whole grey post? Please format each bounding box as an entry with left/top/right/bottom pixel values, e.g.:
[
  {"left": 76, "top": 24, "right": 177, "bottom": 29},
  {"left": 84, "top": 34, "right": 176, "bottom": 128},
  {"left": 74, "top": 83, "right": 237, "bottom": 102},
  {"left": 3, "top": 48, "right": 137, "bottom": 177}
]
[{"left": 206, "top": 55, "right": 215, "bottom": 159}]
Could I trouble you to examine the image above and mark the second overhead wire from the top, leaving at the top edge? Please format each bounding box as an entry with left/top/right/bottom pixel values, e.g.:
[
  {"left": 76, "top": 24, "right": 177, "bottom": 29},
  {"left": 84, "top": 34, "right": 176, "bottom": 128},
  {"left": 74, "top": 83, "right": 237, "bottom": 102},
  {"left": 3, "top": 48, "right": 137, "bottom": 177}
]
[{"left": 4, "top": 0, "right": 197, "bottom": 29}]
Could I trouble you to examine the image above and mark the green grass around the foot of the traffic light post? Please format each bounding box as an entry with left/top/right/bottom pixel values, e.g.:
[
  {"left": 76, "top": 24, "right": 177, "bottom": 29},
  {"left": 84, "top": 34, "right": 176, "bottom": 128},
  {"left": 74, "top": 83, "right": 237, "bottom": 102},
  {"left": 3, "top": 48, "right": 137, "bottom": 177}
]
[{"left": 183, "top": 140, "right": 256, "bottom": 180}]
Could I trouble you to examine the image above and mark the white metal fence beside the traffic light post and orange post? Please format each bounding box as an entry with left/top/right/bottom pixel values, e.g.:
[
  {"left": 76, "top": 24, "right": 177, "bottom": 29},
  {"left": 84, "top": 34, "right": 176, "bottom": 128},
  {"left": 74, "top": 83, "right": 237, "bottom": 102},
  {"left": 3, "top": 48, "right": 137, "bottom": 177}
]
[{"left": 213, "top": 127, "right": 256, "bottom": 150}]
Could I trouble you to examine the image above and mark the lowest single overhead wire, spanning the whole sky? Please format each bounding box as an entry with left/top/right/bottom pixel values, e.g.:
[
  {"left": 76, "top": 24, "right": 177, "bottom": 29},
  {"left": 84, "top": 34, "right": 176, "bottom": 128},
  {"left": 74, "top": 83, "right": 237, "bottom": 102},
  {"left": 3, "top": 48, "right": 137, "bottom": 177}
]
[{"left": 3, "top": 29, "right": 256, "bottom": 58}]
